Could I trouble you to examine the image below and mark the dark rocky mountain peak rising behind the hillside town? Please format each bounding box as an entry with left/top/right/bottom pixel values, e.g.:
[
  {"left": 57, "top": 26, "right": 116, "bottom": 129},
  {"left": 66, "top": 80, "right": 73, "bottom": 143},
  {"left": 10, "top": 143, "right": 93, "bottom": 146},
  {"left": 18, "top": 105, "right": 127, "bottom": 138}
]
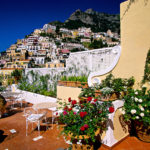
[{"left": 49, "top": 9, "right": 120, "bottom": 33}]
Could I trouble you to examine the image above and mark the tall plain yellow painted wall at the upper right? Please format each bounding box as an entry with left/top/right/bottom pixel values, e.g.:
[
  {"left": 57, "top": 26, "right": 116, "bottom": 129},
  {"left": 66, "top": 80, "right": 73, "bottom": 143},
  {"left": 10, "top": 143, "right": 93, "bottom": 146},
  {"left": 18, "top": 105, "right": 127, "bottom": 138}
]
[{"left": 113, "top": 0, "right": 150, "bottom": 82}]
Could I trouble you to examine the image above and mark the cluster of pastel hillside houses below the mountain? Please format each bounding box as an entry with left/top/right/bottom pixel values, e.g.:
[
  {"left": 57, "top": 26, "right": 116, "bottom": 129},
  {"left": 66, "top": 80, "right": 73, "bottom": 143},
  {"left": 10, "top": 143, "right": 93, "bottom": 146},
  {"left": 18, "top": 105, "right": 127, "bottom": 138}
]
[{"left": 0, "top": 24, "right": 120, "bottom": 69}]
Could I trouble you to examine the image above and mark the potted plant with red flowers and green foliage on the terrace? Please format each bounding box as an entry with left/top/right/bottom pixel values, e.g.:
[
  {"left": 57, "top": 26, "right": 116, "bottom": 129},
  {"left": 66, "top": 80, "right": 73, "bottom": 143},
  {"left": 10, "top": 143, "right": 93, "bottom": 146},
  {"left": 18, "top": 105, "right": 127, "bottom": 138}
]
[{"left": 59, "top": 98, "right": 114, "bottom": 149}]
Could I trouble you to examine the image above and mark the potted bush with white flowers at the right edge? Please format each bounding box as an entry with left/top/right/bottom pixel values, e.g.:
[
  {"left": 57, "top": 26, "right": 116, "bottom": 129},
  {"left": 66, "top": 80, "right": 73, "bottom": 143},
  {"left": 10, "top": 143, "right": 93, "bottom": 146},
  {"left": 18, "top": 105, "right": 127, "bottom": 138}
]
[{"left": 124, "top": 87, "right": 150, "bottom": 142}]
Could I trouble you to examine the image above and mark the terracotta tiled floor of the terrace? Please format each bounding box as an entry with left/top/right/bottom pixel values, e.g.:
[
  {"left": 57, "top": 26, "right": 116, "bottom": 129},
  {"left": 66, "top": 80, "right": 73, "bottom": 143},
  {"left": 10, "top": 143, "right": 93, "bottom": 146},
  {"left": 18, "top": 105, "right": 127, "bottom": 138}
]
[{"left": 0, "top": 106, "right": 150, "bottom": 150}]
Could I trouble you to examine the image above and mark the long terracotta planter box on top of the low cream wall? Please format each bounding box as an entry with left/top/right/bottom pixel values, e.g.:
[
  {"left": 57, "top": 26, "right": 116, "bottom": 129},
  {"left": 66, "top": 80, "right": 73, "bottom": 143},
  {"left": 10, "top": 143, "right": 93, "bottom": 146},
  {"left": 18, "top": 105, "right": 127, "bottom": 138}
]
[{"left": 58, "top": 81, "right": 88, "bottom": 88}]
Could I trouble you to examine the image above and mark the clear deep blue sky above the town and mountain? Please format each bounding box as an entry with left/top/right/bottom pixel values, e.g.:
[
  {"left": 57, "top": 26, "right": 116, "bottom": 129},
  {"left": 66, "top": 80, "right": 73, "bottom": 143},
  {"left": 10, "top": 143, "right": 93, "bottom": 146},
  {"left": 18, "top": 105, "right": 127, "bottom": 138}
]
[{"left": 0, "top": 0, "right": 125, "bottom": 51}]
